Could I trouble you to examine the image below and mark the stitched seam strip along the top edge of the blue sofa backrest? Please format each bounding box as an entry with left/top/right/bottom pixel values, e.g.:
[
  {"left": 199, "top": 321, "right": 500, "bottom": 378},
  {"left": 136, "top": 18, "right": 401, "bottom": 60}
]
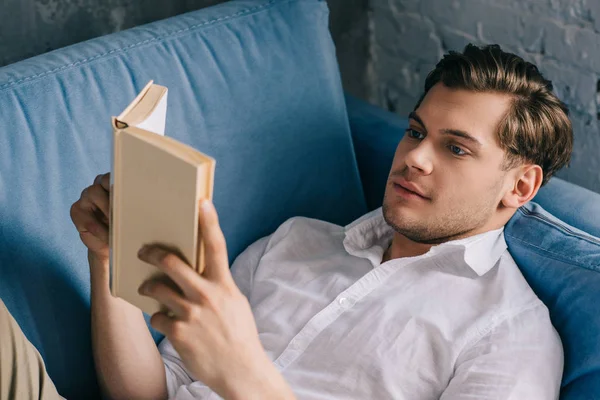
[{"left": 0, "top": 0, "right": 291, "bottom": 91}]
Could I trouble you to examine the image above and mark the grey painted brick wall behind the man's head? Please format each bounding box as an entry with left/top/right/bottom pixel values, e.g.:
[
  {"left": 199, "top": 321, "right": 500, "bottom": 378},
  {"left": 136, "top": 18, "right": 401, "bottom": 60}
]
[{"left": 366, "top": 0, "right": 600, "bottom": 192}]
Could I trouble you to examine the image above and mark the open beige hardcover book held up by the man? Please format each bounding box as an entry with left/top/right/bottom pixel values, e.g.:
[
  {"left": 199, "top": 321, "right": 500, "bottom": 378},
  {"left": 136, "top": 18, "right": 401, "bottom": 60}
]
[{"left": 109, "top": 81, "right": 215, "bottom": 314}]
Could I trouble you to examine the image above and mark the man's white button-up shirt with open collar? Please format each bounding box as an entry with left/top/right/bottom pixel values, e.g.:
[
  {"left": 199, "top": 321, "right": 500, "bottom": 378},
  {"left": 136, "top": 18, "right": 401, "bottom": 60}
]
[{"left": 159, "top": 208, "right": 563, "bottom": 400}]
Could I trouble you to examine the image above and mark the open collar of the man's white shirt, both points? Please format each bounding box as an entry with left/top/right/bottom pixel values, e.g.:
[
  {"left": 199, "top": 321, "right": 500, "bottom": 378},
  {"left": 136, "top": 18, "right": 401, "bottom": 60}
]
[{"left": 344, "top": 207, "right": 507, "bottom": 276}]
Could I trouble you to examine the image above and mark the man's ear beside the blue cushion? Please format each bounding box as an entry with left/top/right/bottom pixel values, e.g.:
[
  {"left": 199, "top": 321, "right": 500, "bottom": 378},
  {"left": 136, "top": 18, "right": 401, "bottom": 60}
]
[{"left": 502, "top": 164, "right": 544, "bottom": 209}]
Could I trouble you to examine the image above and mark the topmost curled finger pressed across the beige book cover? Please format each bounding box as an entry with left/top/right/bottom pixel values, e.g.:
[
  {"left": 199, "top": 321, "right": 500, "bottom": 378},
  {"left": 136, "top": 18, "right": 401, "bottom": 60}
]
[{"left": 138, "top": 245, "right": 214, "bottom": 301}]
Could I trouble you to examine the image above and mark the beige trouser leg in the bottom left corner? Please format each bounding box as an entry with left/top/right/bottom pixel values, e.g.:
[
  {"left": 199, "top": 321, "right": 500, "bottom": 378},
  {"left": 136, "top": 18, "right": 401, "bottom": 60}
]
[{"left": 0, "top": 299, "right": 62, "bottom": 400}]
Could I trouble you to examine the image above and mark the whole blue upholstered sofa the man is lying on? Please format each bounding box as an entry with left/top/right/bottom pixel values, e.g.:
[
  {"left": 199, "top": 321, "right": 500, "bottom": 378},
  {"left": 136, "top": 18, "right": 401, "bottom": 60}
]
[{"left": 0, "top": 0, "right": 600, "bottom": 400}]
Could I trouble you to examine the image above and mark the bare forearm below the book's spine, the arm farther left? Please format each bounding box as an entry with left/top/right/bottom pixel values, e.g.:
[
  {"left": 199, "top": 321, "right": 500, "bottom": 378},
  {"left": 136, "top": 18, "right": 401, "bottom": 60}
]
[{"left": 89, "top": 253, "right": 167, "bottom": 399}]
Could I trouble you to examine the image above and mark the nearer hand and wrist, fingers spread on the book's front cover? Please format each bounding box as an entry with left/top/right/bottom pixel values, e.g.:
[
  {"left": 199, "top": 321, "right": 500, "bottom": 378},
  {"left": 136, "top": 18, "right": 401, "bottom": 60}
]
[{"left": 138, "top": 201, "right": 295, "bottom": 399}]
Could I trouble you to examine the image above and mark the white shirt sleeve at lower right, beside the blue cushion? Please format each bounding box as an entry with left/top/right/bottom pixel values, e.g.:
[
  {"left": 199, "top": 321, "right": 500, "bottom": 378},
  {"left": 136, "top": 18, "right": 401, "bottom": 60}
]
[{"left": 440, "top": 302, "right": 564, "bottom": 400}]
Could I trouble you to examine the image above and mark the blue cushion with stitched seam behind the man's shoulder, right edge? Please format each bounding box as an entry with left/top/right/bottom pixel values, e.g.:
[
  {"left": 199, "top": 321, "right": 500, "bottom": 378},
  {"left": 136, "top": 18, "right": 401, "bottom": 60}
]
[{"left": 504, "top": 203, "right": 600, "bottom": 400}]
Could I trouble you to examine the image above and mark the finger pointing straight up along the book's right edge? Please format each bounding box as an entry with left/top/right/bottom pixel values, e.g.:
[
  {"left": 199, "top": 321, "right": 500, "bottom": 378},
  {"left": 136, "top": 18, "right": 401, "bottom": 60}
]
[{"left": 198, "top": 200, "right": 233, "bottom": 282}]
